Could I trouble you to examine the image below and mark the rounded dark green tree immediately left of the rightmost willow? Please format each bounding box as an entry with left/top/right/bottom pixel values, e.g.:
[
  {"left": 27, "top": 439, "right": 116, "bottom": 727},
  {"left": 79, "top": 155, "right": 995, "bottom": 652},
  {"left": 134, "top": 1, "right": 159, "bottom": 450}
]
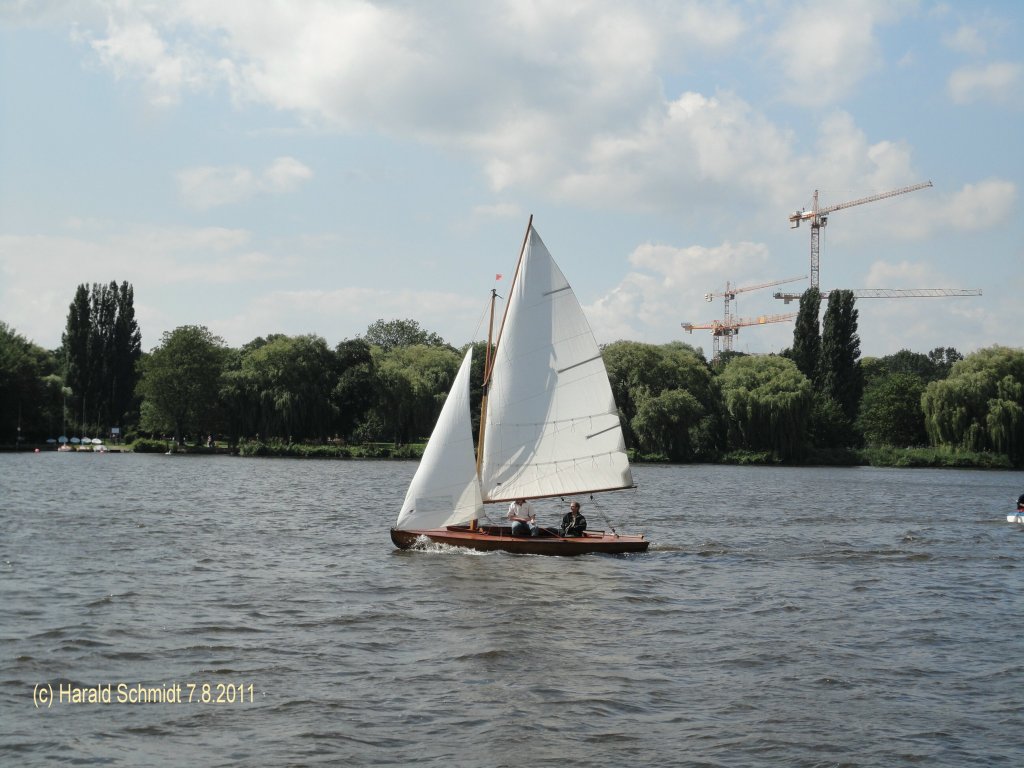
[{"left": 857, "top": 373, "right": 928, "bottom": 447}]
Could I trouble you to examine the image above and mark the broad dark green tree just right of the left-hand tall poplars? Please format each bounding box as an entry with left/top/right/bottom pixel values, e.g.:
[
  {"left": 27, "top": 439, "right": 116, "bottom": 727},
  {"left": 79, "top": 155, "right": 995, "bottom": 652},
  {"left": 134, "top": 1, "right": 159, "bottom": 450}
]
[{"left": 138, "top": 326, "right": 228, "bottom": 444}]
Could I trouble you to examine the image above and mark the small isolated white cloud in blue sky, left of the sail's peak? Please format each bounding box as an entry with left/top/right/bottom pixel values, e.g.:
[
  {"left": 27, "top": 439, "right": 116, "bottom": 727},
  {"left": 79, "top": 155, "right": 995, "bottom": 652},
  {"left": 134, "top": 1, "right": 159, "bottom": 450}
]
[{"left": 177, "top": 158, "right": 313, "bottom": 210}]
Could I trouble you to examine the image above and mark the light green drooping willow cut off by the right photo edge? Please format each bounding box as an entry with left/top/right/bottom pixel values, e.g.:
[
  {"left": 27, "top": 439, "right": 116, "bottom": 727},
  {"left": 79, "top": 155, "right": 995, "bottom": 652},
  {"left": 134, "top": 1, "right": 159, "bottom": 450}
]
[{"left": 921, "top": 346, "right": 1024, "bottom": 464}]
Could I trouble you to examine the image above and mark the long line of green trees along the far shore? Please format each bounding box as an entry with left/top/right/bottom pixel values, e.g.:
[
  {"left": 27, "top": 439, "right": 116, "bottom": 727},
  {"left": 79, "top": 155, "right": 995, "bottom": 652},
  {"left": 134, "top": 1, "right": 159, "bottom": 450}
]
[{"left": 0, "top": 283, "right": 1024, "bottom": 466}]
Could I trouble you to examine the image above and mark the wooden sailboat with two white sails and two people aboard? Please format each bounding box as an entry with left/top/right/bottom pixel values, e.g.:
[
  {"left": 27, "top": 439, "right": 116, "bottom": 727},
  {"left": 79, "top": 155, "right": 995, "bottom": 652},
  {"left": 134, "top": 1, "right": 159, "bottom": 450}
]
[{"left": 391, "top": 217, "right": 650, "bottom": 555}]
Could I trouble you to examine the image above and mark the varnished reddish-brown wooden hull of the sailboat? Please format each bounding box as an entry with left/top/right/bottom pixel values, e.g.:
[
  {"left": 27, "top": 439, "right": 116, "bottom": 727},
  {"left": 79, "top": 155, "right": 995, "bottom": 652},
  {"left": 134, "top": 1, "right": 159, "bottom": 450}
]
[{"left": 391, "top": 525, "right": 650, "bottom": 555}]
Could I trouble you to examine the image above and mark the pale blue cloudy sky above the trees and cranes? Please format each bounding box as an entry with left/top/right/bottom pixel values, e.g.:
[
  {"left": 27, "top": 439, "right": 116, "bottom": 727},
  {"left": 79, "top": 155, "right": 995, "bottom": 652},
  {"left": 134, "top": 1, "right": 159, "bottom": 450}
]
[{"left": 0, "top": 0, "right": 1024, "bottom": 357}]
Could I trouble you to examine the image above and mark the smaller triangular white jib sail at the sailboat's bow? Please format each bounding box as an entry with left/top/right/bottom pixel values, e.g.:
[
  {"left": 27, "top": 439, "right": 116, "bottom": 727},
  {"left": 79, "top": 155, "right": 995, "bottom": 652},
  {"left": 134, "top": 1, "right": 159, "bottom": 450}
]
[{"left": 396, "top": 348, "right": 483, "bottom": 529}]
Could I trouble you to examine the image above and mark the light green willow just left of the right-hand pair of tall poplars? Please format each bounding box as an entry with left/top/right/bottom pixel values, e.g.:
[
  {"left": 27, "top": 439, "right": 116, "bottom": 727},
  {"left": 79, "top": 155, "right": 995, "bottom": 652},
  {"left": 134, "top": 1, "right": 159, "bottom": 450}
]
[{"left": 719, "top": 357, "right": 812, "bottom": 461}]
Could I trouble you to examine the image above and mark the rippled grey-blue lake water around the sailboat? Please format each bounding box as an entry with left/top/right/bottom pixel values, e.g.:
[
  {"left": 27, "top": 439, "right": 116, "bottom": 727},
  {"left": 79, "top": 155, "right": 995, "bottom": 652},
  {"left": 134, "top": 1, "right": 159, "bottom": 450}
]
[{"left": 0, "top": 453, "right": 1024, "bottom": 768}]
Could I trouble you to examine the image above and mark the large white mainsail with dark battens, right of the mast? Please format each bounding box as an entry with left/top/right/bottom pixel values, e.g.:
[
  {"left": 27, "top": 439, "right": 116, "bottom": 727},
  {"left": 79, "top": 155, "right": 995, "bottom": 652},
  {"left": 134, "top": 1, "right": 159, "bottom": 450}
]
[{"left": 481, "top": 228, "right": 633, "bottom": 502}]
